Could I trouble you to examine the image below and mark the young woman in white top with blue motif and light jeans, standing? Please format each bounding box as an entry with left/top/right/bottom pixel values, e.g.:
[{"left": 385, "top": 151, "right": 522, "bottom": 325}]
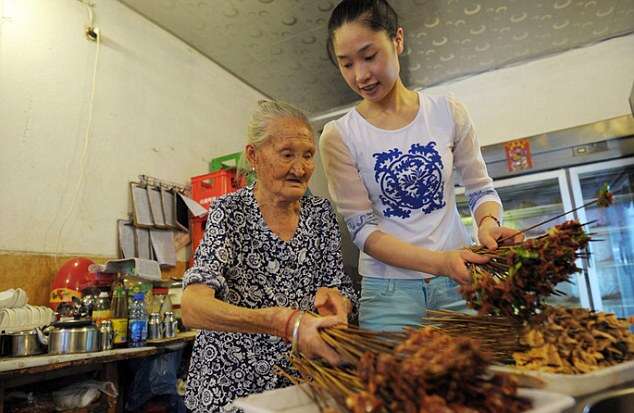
[{"left": 320, "top": 0, "right": 516, "bottom": 330}]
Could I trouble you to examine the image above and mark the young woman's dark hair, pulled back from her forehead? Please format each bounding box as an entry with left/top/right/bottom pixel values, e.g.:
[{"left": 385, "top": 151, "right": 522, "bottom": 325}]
[{"left": 326, "top": 0, "right": 398, "bottom": 66}]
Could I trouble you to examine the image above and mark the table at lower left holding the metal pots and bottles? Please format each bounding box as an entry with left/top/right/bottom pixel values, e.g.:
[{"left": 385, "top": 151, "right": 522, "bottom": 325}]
[{"left": 0, "top": 331, "right": 197, "bottom": 413}]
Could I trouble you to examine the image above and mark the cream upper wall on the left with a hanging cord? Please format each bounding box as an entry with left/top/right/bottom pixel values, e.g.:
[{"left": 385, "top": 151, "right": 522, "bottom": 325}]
[{"left": 0, "top": 0, "right": 262, "bottom": 256}]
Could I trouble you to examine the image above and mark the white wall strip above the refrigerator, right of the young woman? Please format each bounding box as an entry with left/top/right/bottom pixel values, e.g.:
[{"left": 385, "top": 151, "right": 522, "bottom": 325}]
[{"left": 427, "top": 35, "right": 634, "bottom": 146}]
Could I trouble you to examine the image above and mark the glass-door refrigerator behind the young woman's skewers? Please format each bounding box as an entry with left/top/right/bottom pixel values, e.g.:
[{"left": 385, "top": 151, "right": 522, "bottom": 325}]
[{"left": 456, "top": 116, "right": 634, "bottom": 317}]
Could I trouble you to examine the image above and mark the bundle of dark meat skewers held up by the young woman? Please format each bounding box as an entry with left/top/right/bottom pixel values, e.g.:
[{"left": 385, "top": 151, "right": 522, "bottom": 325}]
[{"left": 461, "top": 185, "right": 613, "bottom": 321}]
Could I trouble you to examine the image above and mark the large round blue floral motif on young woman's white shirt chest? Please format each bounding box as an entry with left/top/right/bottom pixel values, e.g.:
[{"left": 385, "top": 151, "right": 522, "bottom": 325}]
[{"left": 373, "top": 142, "right": 446, "bottom": 218}]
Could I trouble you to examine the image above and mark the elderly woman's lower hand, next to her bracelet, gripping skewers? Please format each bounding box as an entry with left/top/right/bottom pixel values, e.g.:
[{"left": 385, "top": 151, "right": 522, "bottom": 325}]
[{"left": 298, "top": 313, "right": 342, "bottom": 366}]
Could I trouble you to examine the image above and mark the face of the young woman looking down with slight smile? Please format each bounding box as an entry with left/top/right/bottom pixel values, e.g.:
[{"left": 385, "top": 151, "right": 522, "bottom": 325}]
[{"left": 333, "top": 22, "right": 403, "bottom": 102}]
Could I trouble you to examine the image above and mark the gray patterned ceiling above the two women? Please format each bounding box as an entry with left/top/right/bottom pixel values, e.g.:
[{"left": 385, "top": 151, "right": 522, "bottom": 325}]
[{"left": 120, "top": 0, "right": 634, "bottom": 115}]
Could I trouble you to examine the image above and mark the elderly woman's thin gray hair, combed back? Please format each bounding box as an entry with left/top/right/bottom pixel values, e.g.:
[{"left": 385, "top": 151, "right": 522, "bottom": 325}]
[{"left": 239, "top": 100, "right": 313, "bottom": 174}]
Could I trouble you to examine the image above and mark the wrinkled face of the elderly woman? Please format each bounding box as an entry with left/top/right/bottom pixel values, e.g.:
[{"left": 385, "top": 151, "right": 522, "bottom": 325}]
[{"left": 253, "top": 117, "right": 316, "bottom": 201}]
